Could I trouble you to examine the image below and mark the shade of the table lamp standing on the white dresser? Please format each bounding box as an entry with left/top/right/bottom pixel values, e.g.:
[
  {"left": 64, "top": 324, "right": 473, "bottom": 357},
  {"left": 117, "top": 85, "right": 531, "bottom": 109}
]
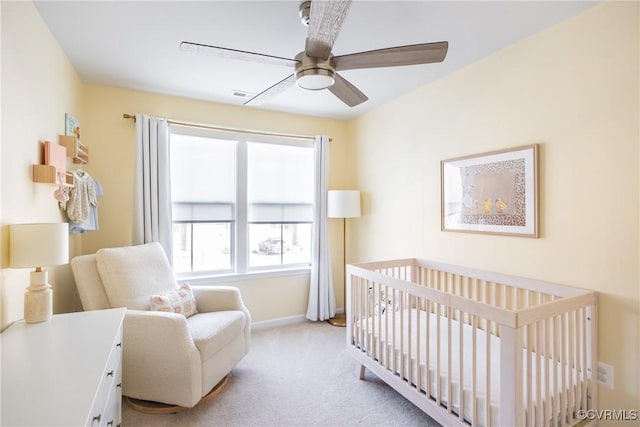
[{"left": 9, "top": 222, "right": 69, "bottom": 268}]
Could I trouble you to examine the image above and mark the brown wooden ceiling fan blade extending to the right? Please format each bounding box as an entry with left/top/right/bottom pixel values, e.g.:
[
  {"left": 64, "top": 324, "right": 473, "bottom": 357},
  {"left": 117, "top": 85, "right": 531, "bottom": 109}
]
[{"left": 333, "top": 42, "right": 449, "bottom": 71}]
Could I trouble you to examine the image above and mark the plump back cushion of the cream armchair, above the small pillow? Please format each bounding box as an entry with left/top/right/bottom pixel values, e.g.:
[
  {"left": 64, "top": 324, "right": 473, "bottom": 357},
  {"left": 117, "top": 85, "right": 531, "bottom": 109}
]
[{"left": 96, "top": 242, "right": 178, "bottom": 310}]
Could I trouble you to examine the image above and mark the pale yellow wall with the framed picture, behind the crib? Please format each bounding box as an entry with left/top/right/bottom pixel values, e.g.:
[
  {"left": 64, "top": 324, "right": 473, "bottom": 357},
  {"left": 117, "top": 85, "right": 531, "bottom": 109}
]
[{"left": 350, "top": 2, "right": 640, "bottom": 418}]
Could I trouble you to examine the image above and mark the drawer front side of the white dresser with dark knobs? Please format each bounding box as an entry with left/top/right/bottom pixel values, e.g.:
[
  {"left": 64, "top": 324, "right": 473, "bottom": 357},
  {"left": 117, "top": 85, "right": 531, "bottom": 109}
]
[{"left": 90, "top": 328, "right": 122, "bottom": 427}]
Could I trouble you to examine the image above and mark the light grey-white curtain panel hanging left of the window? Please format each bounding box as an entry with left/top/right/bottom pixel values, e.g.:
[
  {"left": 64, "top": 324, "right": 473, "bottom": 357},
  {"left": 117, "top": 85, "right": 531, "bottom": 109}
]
[{"left": 132, "top": 114, "right": 173, "bottom": 262}]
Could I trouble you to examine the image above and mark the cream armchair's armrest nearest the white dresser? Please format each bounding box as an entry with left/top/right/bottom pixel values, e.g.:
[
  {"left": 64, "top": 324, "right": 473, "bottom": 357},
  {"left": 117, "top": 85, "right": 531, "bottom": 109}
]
[{"left": 122, "top": 310, "right": 202, "bottom": 407}]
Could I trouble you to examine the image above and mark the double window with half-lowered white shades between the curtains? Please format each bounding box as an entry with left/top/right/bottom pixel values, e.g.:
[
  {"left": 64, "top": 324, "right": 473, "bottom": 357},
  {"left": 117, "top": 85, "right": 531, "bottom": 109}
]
[{"left": 170, "top": 126, "right": 315, "bottom": 275}]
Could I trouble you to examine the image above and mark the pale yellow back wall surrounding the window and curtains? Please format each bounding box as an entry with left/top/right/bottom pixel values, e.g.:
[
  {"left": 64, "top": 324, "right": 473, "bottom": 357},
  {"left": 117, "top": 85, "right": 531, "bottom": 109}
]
[{"left": 82, "top": 85, "right": 354, "bottom": 321}]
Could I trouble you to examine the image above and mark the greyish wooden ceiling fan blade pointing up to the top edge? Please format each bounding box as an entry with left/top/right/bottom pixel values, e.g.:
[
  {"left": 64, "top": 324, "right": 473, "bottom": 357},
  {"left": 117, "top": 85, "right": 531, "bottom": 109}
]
[{"left": 305, "top": 0, "right": 351, "bottom": 59}]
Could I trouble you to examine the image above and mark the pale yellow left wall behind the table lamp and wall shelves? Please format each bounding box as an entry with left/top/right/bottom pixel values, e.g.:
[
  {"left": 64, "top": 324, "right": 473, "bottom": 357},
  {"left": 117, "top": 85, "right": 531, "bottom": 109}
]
[{"left": 0, "top": 1, "right": 83, "bottom": 329}]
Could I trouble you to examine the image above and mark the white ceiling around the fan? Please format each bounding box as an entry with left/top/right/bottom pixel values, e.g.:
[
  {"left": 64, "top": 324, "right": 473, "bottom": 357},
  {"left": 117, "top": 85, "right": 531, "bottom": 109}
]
[{"left": 35, "top": 0, "right": 598, "bottom": 118}]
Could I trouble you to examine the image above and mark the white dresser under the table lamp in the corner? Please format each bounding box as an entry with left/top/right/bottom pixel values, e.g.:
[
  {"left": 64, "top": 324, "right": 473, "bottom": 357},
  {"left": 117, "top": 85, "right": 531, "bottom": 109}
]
[{"left": 0, "top": 308, "right": 126, "bottom": 427}]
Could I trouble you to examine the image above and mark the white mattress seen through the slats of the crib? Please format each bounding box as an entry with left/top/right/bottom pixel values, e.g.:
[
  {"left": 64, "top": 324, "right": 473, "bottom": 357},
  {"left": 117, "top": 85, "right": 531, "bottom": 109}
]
[{"left": 356, "top": 308, "right": 578, "bottom": 425}]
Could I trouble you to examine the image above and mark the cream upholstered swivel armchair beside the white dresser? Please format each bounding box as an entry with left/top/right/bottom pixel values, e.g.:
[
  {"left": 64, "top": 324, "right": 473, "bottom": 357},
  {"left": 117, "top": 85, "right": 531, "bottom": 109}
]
[{"left": 71, "top": 243, "right": 251, "bottom": 408}]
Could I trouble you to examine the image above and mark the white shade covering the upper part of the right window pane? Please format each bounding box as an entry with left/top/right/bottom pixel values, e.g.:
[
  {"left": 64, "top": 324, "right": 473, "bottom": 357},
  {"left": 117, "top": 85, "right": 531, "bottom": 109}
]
[{"left": 247, "top": 142, "right": 314, "bottom": 223}]
